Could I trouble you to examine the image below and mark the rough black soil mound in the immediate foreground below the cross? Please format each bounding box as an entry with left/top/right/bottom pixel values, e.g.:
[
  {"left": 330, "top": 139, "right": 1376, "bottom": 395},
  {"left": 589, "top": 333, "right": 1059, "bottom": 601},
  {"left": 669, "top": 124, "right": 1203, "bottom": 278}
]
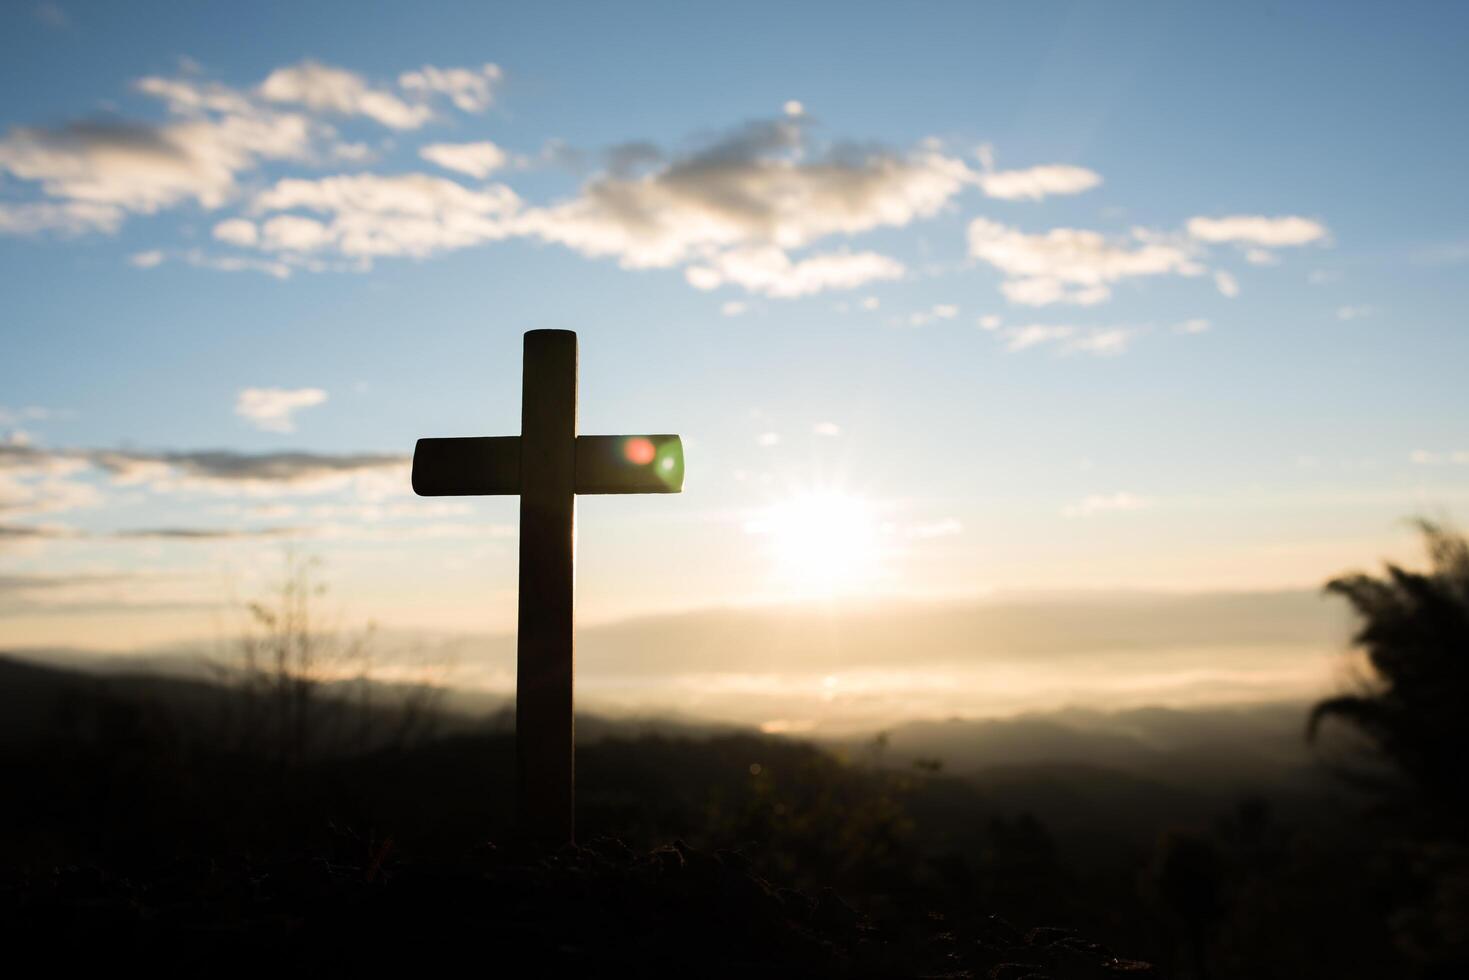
[{"left": 0, "top": 837, "right": 1156, "bottom": 980}]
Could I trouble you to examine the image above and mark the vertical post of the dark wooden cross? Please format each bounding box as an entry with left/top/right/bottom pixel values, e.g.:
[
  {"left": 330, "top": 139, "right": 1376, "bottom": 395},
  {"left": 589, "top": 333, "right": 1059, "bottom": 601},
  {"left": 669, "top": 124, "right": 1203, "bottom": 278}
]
[{"left": 516, "top": 331, "right": 577, "bottom": 843}]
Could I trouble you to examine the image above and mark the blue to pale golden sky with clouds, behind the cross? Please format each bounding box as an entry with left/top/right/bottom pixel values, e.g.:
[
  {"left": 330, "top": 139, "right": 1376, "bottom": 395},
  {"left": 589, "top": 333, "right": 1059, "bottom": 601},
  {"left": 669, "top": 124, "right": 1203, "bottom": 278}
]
[{"left": 0, "top": 3, "right": 1469, "bottom": 728}]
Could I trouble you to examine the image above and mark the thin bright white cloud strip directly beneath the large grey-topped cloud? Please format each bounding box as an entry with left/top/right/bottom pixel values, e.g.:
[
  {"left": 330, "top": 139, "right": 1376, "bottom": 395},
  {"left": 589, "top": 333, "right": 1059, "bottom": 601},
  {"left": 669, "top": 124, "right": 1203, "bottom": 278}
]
[{"left": 683, "top": 247, "right": 906, "bottom": 298}]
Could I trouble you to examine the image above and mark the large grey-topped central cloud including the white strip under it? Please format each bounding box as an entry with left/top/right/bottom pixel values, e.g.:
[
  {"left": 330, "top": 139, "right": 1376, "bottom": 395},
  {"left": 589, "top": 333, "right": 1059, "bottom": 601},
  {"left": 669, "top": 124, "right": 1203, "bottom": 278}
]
[{"left": 520, "top": 116, "right": 972, "bottom": 295}]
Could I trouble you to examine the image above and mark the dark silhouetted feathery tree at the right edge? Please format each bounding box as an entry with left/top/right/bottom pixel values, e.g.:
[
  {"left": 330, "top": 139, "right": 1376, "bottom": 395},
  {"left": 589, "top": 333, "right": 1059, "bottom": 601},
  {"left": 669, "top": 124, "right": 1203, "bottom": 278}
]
[{"left": 1307, "top": 520, "right": 1469, "bottom": 820}]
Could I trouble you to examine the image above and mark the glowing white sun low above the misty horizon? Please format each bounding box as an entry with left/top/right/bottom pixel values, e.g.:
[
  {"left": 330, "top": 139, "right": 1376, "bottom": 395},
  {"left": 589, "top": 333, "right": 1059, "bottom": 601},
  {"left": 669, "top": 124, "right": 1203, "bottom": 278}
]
[{"left": 749, "top": 489, "right": 881, "bottom": 595}]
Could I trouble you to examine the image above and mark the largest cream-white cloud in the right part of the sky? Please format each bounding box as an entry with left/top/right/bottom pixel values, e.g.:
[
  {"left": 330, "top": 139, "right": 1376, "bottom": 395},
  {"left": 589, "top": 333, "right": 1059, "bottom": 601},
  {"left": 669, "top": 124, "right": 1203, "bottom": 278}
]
[{"left": 968, "top": 217, "right": 1203, "bottom": 306}]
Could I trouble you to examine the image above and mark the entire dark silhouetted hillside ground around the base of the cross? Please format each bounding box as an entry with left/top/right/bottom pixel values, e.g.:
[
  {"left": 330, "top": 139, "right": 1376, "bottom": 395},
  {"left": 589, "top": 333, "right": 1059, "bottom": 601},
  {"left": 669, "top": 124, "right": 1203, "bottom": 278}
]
[{"left": 0, "top": 658, "right": 1451, "bottom": 980}]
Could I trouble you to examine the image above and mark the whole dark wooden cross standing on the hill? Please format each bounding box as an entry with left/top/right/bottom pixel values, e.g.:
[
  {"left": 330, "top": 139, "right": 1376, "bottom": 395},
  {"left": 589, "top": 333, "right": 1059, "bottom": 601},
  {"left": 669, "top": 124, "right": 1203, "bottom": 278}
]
[{"left": 413, "top": 331, "right": 683, "bottom": 843}]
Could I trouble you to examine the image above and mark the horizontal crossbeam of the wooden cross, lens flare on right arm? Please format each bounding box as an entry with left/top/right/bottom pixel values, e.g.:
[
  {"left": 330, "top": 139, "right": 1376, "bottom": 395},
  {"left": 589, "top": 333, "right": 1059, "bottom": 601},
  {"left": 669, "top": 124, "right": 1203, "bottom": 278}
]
[{"left": 413, "top": 435, "right": 683, "bottom": 497}]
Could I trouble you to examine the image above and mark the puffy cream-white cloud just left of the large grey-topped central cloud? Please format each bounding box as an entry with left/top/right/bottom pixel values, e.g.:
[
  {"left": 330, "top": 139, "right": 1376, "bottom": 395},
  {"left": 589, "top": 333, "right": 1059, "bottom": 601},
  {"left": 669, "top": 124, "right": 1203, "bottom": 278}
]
[{"left": 253, "top": 173, "right": 520, "bottom": 259}]
